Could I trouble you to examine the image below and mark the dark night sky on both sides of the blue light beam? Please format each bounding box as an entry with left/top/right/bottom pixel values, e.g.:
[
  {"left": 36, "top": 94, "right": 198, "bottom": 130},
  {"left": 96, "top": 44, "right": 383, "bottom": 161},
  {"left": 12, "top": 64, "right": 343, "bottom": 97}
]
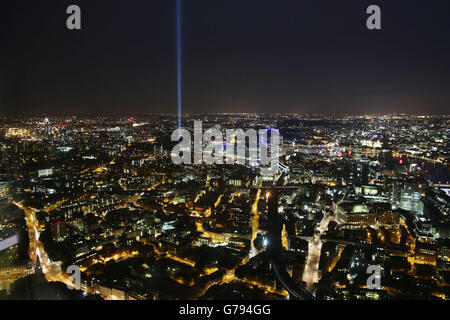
[{"left": 0, "top": 0, "right": 450, "bottom": 115}]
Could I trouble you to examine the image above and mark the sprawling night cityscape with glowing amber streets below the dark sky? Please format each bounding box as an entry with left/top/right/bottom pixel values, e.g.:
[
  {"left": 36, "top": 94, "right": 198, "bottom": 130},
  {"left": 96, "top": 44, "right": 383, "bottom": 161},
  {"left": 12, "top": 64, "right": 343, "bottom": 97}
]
[{"left": 0, "top": 114, "right": 450, "bottom": 300}]
